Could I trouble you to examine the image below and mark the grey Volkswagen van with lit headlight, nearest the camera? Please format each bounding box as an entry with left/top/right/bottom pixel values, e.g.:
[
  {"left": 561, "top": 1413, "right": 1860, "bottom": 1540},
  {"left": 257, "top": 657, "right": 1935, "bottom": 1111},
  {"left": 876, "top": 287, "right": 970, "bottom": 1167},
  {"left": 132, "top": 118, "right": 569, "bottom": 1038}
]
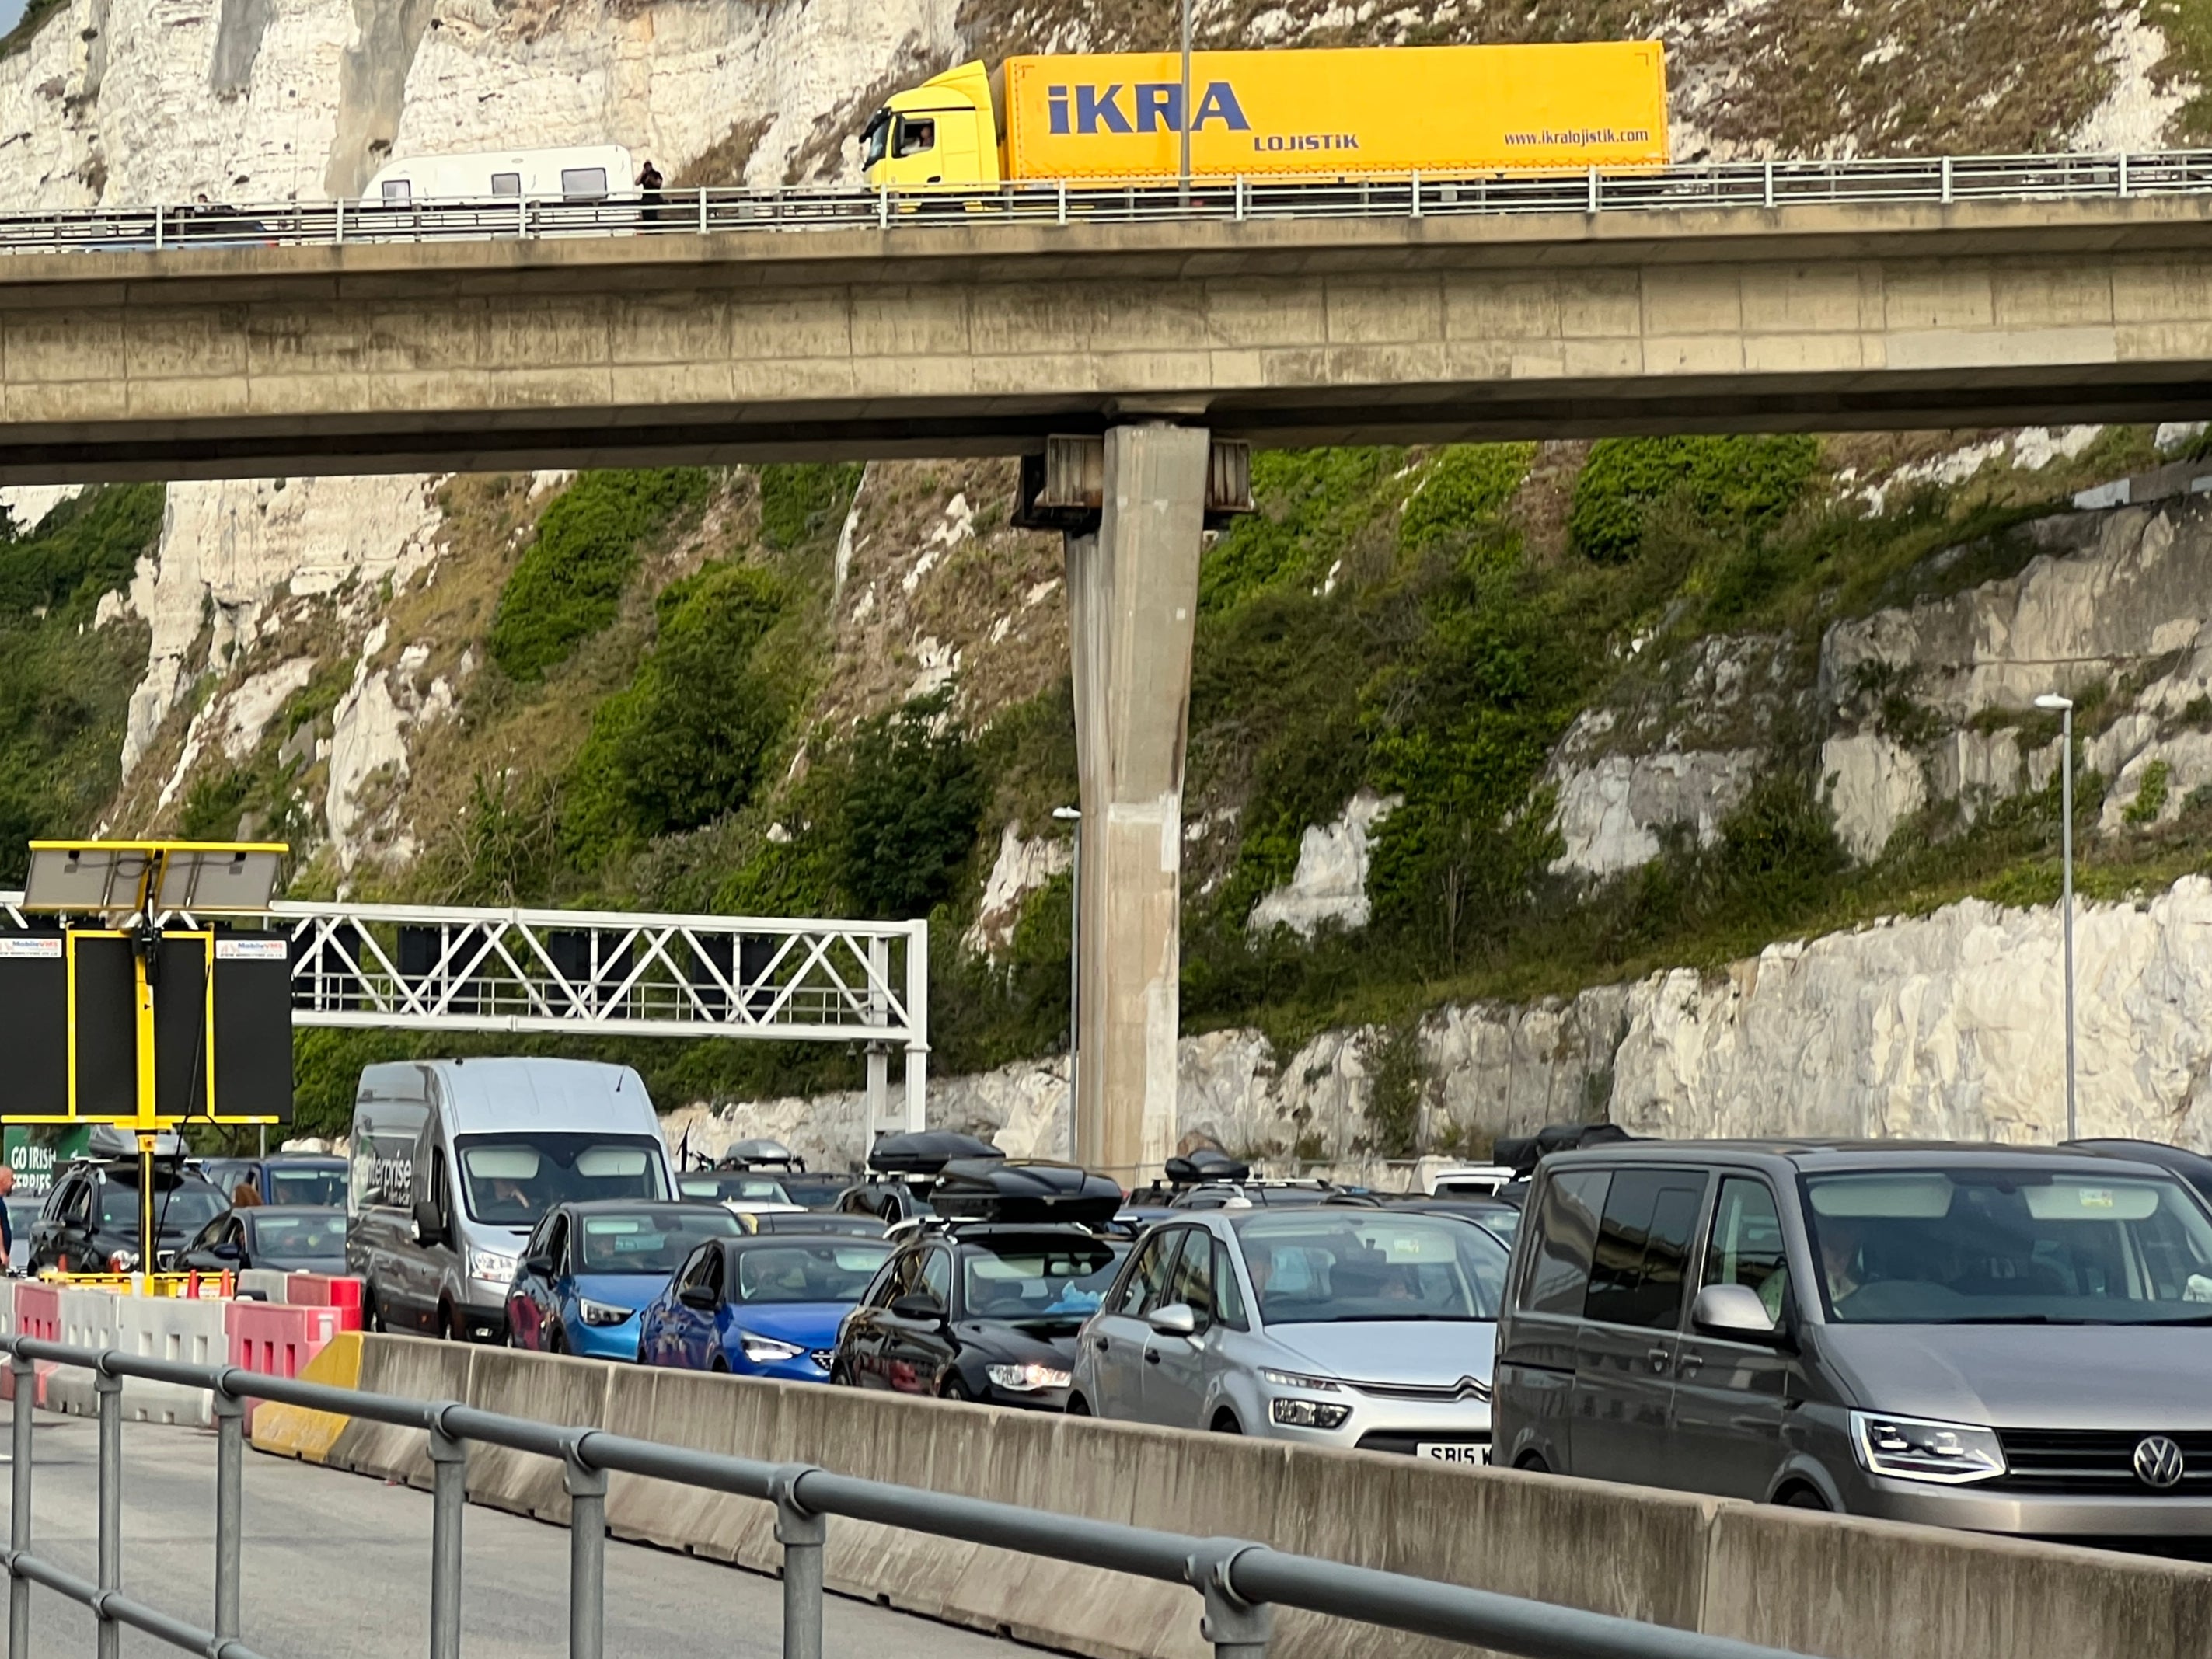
[{"left": 1493, "top": 1141, "right": 2212, "bottom": 1549}]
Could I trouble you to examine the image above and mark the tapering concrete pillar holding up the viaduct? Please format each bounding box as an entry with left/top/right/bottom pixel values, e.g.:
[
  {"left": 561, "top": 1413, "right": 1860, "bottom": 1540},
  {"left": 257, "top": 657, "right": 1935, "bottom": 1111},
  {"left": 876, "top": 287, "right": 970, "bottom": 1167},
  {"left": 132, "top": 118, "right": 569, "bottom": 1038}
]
[{"left": 1066, "top": 423, "right": 1210, "bottom": 1186}]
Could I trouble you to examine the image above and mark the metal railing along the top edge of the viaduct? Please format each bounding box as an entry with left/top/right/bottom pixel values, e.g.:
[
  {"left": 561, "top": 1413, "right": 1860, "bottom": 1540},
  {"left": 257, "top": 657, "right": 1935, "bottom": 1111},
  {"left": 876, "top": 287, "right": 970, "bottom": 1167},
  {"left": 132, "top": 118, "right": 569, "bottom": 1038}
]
[{"left": 12, "top": 151, "right": 2212, "bottom": 253}]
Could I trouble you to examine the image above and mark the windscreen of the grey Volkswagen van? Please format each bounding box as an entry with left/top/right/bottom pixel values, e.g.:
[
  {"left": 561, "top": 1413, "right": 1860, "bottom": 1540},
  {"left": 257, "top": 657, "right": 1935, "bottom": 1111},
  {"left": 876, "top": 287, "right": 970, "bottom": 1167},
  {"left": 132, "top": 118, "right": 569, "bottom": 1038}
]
[{"left": 1805, "top": 1168, "right": 2212, "bottom": 1325}]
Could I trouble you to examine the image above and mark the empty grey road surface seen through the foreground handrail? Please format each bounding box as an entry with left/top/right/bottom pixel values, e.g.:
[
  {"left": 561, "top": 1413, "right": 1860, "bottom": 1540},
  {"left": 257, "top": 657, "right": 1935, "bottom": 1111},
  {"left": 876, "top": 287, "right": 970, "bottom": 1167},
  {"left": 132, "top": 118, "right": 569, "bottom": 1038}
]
[{"left": 0, "top": 1413, "right": 1035, "bottom": 1659}]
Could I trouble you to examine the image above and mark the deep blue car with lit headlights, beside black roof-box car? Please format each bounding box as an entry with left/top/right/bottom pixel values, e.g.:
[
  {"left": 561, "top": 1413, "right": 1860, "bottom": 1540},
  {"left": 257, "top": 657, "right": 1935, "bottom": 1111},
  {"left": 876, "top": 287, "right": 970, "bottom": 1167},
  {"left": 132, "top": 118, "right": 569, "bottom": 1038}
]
[{"left": 637, "top": 1232, "right": 891, "bottom": 1382}]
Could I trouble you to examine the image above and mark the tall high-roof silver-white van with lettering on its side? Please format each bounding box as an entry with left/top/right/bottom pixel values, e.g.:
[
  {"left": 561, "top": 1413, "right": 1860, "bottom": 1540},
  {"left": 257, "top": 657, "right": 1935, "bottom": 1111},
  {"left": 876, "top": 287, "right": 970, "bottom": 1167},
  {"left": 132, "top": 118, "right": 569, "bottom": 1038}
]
[{"left": 345, "top": 1060, "right": 675, "bottom": 1343}]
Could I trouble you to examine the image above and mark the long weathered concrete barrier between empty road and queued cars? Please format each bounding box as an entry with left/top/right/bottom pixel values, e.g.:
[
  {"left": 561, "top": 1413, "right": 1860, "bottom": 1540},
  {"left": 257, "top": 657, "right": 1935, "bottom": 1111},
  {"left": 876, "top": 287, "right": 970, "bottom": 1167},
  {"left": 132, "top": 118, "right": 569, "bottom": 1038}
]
[{"left": 285, "top": 1336, "right": 2212, "bottom": 1659}]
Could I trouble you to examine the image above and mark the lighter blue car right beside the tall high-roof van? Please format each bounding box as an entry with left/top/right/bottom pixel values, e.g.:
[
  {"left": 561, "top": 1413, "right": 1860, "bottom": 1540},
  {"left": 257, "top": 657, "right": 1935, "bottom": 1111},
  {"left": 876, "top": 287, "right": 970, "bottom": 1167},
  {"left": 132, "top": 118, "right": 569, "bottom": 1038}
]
[{"left": 507, "top": 1199, "right": 739, "bottom": 1361}]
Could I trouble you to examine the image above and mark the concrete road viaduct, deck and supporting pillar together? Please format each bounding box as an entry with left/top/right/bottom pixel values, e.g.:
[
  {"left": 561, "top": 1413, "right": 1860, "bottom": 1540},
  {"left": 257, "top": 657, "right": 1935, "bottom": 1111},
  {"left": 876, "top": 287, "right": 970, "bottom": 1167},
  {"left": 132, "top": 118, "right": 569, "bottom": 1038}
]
[{"left": 17, "top": 197, "right": 2212, "bottom": 1176}]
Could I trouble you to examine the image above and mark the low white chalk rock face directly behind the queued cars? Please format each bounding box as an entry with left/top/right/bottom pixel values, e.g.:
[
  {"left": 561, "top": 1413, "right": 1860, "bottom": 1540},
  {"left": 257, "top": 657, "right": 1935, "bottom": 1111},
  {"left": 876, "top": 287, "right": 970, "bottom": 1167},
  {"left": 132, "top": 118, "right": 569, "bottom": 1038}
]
[{"left": 699, "top": 876, "right": 2212, "bottom": 1166}]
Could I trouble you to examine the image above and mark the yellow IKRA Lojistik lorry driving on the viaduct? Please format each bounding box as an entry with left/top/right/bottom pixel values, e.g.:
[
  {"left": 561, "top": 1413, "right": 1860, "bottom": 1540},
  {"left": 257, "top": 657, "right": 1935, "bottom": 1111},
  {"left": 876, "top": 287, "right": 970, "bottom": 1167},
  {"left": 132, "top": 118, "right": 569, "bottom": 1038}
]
[{"left": 863, "top": 40, "right": 1668, "bottom": 190}]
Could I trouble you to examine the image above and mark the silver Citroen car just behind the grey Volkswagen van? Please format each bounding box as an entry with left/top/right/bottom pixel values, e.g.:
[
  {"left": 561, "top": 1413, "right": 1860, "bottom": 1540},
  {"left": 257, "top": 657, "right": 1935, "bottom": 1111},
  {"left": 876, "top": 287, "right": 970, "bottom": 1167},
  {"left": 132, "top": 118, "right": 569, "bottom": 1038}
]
[{"left": 1069, "top": 1204, "right": 1506, "bottom": 1462}]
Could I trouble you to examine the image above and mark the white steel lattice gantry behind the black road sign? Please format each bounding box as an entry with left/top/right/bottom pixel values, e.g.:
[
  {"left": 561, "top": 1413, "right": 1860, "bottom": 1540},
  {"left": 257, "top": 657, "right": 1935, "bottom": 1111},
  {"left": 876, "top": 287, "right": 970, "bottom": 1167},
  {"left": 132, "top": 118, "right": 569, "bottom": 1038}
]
[{"left": 0, "top": 894, "right": 929, "bottom": 1131}]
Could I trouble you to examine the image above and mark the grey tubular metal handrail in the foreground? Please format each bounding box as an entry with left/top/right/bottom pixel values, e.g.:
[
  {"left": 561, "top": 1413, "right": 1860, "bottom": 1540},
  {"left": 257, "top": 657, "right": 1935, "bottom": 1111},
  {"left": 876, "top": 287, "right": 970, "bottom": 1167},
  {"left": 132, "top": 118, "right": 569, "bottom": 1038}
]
[{"left": 0, "top": 1336, "right": 1796, "bottom": 1659}]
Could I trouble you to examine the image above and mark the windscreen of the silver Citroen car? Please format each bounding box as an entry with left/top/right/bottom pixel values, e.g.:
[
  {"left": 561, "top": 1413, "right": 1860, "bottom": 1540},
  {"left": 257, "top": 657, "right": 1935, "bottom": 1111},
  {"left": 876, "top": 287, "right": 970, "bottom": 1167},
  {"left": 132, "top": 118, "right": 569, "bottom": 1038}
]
[{"left": 1237, "top": 1210, "right": 1506, "bottom": 1325}]
